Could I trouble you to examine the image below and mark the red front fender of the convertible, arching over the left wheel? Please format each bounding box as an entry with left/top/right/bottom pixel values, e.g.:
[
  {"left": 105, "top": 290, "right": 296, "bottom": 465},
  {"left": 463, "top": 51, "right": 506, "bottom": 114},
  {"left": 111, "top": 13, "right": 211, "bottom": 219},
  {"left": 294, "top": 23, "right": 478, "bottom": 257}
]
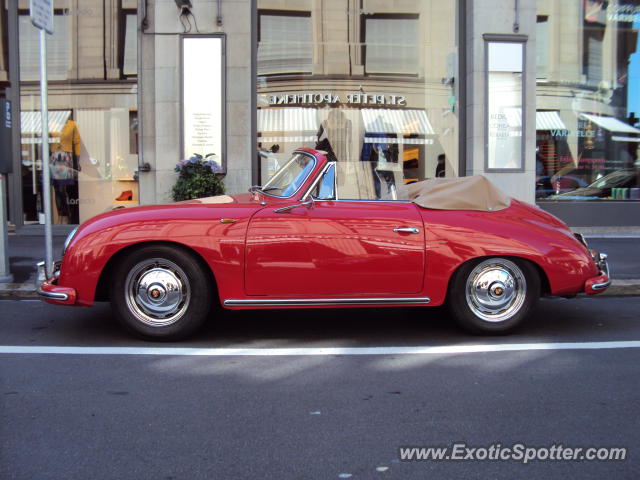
[{"left": 58, "top": 204, "right": 256, "bottom": 305}]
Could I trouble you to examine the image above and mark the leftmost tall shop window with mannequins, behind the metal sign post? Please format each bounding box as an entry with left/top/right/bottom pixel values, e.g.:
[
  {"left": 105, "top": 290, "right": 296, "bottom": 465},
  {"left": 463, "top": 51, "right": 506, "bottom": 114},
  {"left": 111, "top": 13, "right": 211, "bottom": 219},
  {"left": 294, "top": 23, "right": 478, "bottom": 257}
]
[{"left": 18, "top": 1, "right": 138, "bottom": 224}]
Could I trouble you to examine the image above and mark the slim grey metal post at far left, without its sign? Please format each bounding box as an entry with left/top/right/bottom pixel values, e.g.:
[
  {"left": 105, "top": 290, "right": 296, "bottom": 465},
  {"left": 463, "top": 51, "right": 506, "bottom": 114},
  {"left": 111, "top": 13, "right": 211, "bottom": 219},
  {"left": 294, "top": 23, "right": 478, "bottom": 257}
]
[{"left": 40, "top": 28, "right": 53, "bottom": 278}]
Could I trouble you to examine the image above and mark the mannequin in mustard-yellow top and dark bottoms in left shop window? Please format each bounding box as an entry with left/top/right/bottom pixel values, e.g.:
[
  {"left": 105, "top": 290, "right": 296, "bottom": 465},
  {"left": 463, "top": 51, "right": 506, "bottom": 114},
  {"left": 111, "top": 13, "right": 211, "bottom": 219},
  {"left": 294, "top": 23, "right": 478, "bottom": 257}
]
[{"left": 50, "top": 119, "right": 80, "bottom": 224}]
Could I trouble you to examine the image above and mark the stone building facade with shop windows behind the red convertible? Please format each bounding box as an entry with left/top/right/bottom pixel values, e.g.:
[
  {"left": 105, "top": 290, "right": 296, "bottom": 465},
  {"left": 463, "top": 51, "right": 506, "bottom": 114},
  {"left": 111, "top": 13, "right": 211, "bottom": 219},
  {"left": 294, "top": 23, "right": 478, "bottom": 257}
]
[{"left": 0, "top": 0, "right": 640, "bottom": 226}]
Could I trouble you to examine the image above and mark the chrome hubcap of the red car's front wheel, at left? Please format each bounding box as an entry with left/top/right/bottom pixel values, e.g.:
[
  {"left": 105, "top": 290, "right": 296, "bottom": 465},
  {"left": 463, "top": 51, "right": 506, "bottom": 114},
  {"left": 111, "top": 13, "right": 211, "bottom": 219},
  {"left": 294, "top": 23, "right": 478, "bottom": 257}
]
[{"left": 126, "top": 258, "right": 191, "bottom": 327}]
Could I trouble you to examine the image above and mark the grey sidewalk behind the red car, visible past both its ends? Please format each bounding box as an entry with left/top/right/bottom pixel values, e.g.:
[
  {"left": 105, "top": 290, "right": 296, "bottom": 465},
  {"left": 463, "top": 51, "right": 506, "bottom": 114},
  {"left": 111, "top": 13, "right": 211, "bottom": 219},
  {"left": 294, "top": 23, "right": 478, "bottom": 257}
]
[{"left": 0, "top": 225, "right": 640, "bottom": 299}]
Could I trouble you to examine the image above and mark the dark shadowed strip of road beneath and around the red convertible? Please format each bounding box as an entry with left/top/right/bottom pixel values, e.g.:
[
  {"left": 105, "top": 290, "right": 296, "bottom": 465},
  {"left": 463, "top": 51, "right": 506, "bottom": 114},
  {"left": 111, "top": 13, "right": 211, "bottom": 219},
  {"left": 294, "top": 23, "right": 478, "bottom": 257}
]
[{"left": 17, "top": 297, "right": 640, "bottom": 348}]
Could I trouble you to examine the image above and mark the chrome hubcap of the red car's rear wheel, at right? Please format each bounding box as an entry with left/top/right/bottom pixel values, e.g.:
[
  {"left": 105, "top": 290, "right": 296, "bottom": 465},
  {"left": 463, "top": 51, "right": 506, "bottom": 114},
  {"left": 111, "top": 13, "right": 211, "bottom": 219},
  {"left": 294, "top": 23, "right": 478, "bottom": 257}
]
[{"left": 466, "top": 259, "right": 527, "bottom": 322}]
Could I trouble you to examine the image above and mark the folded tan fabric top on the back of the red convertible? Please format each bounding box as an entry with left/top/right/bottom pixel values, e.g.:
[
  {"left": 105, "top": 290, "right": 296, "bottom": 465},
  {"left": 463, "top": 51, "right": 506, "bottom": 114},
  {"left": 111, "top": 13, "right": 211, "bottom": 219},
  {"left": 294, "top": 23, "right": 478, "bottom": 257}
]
[{"left": 398, "top": 175, "right": 511, "bottom": 212}]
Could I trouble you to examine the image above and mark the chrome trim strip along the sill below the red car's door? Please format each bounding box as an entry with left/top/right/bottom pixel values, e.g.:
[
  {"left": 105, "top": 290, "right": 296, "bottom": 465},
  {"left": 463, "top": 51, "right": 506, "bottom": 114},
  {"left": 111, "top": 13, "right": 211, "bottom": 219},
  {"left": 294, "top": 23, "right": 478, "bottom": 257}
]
[{"left": 224, "top": 297, "right": 431, "bottom": 307}]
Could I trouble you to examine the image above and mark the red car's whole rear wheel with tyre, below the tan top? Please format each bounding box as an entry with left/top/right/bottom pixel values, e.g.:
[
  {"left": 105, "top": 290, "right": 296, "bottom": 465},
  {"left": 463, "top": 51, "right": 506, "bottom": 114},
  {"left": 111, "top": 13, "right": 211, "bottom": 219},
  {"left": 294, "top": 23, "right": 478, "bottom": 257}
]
[{"left": 448, "top": 257, "right": 540, "bottom": 334}]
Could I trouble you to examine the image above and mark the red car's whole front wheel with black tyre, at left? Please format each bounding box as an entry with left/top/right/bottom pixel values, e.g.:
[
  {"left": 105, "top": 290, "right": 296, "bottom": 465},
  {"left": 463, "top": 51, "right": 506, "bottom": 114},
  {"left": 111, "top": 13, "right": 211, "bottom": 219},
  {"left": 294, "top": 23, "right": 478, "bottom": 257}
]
[{"left": 111, "top": 245, "right": 213, "bottom": 340}]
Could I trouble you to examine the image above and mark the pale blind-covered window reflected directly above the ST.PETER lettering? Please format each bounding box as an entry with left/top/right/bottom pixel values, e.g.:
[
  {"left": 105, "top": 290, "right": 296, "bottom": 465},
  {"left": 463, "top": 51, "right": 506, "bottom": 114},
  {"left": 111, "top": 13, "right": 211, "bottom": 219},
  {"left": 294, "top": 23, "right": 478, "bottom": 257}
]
[{"left": 362, "top": 14, "right": 420, "bottom": 75}]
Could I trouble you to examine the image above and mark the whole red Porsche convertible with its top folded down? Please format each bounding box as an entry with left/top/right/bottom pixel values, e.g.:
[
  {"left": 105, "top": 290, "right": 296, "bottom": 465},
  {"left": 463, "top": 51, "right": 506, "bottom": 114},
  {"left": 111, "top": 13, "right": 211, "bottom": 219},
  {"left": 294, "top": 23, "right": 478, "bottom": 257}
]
[{"left": 38, "top": 149, "right": 610, "bottom": 340}]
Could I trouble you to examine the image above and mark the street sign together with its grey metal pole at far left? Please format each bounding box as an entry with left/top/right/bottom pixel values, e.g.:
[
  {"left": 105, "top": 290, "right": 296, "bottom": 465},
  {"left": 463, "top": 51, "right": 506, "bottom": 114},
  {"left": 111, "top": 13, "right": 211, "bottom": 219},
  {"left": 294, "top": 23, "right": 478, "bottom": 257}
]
[{"left": 29, "top": 0, "right": 53, "bottom": 279}]
